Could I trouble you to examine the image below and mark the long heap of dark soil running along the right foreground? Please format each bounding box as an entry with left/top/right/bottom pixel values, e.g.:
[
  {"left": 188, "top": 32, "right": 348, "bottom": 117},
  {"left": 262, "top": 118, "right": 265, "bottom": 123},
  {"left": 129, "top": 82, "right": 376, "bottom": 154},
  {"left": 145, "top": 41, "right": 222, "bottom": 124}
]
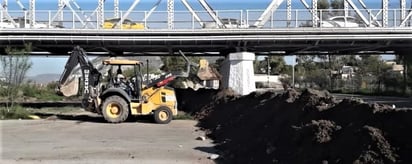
[{"left": 175, "top": 90, "right": 412, "bottom": 163}]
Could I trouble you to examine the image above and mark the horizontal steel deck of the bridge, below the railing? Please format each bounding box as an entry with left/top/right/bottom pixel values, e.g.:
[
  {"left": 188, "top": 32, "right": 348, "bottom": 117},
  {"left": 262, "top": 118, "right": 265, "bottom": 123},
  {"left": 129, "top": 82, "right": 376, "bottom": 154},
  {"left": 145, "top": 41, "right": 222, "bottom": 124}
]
[{"left": 0, "top": 28, "right": 412, "bottom": 55}]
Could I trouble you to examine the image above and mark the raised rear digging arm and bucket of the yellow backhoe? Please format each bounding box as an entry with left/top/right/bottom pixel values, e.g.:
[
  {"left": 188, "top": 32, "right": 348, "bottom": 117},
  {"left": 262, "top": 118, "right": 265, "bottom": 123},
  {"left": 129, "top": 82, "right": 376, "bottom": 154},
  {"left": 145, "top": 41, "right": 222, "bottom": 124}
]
[{"left": 58, "top": 46, "right": 101, "bottom": 97}]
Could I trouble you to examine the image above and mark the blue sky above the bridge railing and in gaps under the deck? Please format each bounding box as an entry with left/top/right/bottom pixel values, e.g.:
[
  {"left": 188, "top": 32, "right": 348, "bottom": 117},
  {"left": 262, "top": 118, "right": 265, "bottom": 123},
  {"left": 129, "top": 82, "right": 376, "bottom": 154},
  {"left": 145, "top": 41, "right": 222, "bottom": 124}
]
[{"left": 1, "top": 0, "right": 396, "bottom": 76}]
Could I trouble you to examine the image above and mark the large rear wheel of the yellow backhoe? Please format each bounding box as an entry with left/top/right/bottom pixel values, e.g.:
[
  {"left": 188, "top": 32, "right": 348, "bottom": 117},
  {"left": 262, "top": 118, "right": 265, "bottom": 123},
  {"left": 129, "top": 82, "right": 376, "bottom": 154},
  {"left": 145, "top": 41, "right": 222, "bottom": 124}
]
[{"left": 102, "top": 96, "right": 129, "bottom": 123}]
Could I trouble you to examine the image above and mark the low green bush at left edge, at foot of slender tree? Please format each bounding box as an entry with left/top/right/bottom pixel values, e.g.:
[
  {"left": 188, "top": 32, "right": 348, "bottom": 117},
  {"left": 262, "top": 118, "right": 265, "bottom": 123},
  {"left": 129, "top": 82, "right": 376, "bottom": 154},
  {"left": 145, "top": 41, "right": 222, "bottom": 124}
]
[{"left": 0, "top": 106, "right": 30, "bottom": 120}]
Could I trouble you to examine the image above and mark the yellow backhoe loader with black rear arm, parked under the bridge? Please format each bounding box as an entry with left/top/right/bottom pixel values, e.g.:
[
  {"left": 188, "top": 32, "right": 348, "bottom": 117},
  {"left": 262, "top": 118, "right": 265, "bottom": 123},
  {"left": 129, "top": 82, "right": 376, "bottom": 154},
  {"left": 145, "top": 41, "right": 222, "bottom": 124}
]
[{"left": 58, "top": 46, "right": 218, "bottom": 124}]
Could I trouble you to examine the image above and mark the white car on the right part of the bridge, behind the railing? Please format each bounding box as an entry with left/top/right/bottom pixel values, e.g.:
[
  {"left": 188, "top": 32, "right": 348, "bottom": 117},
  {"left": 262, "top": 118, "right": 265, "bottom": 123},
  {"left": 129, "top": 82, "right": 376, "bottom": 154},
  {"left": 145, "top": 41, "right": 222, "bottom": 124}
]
[{"left": 320, "top": 16, "right": 367, "bottom": 27}]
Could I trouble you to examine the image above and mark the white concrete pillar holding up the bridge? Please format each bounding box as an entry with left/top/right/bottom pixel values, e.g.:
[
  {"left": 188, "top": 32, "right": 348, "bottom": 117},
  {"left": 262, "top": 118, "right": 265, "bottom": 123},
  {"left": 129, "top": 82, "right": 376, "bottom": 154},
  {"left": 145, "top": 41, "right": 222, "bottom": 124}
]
[{"left": 221, "top": 52, "right": 256, "bottom": 95}]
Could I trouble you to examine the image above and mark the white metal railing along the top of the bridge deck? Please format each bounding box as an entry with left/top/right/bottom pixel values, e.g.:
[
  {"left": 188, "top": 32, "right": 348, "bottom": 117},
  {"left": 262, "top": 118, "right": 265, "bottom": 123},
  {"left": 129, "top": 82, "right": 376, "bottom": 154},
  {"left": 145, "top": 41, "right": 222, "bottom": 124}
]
[{"left": 0, "top": 9, "right": 412, "bottom": 30}]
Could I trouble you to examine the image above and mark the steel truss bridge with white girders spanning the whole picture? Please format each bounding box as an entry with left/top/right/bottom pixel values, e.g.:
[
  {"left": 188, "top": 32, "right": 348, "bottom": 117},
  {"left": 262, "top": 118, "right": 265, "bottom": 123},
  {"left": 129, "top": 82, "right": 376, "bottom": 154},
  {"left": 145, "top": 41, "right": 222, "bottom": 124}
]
[{"left": 0, "top": 0, "right": 412, "bottom": 55}]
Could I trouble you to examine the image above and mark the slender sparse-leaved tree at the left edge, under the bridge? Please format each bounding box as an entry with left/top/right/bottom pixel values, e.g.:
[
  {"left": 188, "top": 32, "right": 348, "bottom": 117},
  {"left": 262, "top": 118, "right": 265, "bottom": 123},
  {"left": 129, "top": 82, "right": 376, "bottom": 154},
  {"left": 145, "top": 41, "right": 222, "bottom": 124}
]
[{"left": 0, "top": 44, "right": 32, "bottom": 112}]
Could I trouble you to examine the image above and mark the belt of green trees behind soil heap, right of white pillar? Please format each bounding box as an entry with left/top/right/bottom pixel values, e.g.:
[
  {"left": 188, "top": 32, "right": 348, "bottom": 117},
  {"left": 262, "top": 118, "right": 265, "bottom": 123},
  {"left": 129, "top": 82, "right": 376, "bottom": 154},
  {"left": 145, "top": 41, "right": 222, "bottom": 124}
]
[{"left": 254, "top": 52, "right": 412, "bottom": 96}]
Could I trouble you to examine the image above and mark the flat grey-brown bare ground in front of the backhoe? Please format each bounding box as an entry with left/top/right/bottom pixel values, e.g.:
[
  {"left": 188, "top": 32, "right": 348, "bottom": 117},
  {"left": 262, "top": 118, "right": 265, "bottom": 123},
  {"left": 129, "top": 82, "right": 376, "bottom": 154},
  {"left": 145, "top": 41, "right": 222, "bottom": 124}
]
[{"left": 0, "top": 120, "right": 214, "bottom": 163}]
